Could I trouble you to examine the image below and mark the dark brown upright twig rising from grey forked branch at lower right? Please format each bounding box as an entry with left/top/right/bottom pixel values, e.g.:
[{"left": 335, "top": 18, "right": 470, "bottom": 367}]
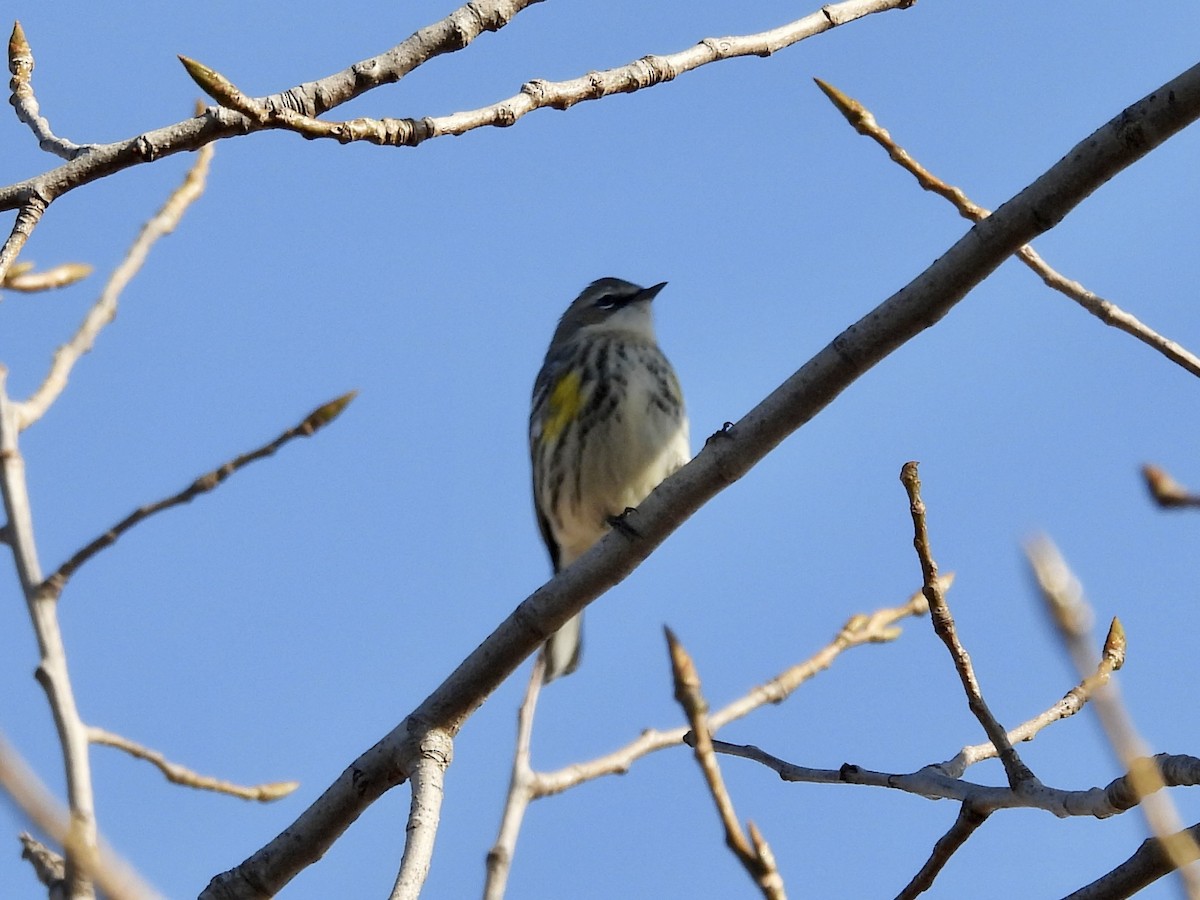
[{"left": 900, "top": 462, "right": 1038, "bottom": 791}]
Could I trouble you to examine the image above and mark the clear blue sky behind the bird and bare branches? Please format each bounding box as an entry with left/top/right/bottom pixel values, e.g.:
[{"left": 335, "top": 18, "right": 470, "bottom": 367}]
[{"left": 0, "top": 0, "right": 1200, "bottom": 899}]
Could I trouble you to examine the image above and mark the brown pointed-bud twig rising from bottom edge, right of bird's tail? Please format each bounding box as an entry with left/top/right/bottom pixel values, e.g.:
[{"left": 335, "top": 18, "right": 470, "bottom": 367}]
[{"left": 664, "top": 629, "right": 787, "bottom": 900}]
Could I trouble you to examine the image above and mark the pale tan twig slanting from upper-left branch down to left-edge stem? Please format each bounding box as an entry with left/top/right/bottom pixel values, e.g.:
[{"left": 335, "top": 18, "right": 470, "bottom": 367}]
[{"left": 20, "top": 133, "right": 212, "bottom": 430}]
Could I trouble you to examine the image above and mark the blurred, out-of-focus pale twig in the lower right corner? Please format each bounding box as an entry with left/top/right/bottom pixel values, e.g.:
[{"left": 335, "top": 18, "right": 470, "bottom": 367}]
[{"left": 1025, "top": 538, "right": 1200, "bottom": 900}]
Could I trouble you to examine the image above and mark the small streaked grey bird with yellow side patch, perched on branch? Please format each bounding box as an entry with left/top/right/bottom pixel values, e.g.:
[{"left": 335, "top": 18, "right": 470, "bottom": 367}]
[{"left": 529, "top": 278, "right": 691, "bottom": 683}]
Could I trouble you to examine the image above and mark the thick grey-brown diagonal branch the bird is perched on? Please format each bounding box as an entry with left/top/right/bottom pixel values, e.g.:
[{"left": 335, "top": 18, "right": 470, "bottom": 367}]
[{"left": 202, "top": 65, "right": 1200, "bottom": 900}]
